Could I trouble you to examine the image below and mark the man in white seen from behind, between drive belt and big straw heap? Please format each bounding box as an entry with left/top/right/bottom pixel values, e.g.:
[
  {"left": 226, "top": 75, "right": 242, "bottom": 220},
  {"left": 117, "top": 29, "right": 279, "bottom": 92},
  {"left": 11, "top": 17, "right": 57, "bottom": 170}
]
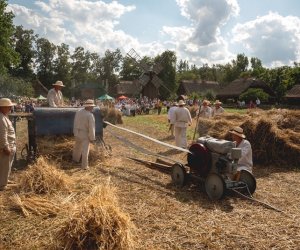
[{"left": 174, "top": 100, "right": 192, "bottom": 148}]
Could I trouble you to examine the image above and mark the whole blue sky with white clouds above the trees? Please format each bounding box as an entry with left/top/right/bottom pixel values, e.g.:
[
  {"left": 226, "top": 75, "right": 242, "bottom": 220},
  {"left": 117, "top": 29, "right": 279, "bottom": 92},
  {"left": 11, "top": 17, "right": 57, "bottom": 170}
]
[{"left": 8, "top": 0, "right": 300, "bottom": 67}]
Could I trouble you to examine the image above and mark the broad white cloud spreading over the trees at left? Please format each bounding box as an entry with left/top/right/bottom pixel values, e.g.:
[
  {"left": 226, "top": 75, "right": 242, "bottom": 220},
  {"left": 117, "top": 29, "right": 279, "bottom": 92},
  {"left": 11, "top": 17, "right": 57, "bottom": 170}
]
[{"left": 8, "top": 0, "right": 146, "bottom": 54}]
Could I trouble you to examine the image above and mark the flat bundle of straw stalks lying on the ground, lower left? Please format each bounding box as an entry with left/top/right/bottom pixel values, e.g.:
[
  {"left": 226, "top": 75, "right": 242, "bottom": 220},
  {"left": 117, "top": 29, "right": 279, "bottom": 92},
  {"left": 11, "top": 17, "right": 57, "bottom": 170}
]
[{"left": 9, "top": 194, "right": 60, "bottom": 217}]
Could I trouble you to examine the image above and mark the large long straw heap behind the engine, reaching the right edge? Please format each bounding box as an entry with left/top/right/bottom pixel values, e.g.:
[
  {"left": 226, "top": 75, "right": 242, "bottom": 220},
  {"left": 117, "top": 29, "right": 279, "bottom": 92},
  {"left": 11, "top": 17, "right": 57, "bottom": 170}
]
[{"left": 198, "top": 110, "right": 300, "bottom": 167}]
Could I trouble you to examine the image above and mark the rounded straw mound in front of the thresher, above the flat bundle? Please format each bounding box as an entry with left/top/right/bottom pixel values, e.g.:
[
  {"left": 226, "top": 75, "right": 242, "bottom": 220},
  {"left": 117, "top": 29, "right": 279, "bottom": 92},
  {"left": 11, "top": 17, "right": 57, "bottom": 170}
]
[{"left": 19, "top": 157, "right": 71, "bottom": 194}]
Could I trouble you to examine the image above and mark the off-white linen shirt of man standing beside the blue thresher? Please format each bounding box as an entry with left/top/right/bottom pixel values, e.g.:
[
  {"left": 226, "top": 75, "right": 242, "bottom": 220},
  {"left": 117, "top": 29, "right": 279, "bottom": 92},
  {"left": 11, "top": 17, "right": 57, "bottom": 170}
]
[{"left": 73, "top": 109, "right": 96, "bottom": 141}]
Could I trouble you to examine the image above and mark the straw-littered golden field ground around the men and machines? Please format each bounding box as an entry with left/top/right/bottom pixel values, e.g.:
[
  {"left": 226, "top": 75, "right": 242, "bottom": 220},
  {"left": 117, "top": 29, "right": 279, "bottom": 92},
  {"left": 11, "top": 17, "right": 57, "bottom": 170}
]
[{"left": 0, "top": 110, "right": 300, "bottom": 249}]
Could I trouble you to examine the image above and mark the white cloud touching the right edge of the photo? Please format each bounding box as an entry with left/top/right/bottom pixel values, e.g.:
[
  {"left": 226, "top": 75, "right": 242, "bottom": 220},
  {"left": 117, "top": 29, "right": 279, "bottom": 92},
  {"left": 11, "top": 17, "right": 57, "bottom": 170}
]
[{"left": 232, "top": 12, "right": 300, "bottom": 66}]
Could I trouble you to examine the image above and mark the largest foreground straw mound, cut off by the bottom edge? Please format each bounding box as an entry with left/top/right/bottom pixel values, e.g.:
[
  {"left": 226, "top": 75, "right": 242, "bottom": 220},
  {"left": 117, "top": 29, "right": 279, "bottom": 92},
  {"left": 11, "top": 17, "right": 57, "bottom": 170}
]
[{"left": 58, "top": 184, "right": 134, "bottom": 249}]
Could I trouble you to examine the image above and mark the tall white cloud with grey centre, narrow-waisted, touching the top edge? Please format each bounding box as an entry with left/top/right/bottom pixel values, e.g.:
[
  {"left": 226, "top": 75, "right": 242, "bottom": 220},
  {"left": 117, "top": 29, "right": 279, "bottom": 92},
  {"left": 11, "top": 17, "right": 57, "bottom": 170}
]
[{"left": 162, "top": 0, "right": 239, "bottom": 65}]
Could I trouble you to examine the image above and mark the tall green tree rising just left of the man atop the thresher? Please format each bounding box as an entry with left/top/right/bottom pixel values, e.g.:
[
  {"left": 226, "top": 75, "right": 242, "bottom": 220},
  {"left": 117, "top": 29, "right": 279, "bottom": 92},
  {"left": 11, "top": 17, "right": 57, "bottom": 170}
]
[{"left": 36, "top": 38, "right": 56, "bottom": 89}]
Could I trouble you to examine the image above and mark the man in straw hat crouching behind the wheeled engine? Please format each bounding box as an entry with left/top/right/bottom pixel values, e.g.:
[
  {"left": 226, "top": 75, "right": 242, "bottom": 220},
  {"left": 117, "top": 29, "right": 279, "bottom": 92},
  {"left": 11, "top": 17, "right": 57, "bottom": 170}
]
[{"left": 229, "top": 127, "right": 253, "bottom": 180}]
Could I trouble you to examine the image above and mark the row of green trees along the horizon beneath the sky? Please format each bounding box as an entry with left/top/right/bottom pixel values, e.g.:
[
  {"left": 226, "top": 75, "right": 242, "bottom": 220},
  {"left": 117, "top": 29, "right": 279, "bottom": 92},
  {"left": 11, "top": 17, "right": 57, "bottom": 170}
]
[{"left": 0, "top": 0, "right": 300, "bottom": 101}]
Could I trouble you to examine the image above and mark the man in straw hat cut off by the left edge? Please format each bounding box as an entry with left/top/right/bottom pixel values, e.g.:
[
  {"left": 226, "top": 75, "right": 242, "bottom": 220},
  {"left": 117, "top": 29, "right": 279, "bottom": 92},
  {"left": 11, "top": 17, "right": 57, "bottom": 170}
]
[{"left": 0, "top": 98, "right": 16, "bottom": 191}]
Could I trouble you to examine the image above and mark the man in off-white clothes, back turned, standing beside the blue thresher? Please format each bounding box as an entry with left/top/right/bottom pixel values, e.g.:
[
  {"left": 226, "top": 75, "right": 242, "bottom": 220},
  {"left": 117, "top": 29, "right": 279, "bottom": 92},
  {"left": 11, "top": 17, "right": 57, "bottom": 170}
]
[{"left": 73, "top": 99, "right": 96, "bottom": 169}]
